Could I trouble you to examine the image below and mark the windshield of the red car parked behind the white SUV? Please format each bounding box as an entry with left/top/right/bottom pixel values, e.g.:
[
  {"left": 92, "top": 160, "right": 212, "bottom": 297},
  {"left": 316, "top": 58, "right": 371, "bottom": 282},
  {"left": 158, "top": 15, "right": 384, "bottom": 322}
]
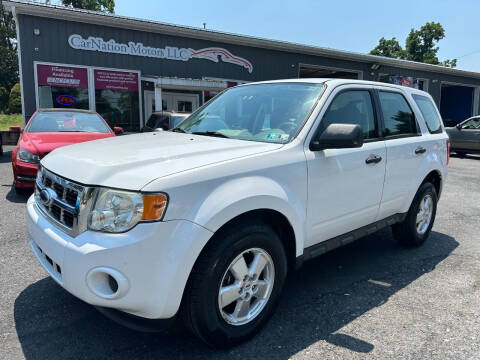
[{"left": 26, "top": 111, "right": 112, "bottom": 133}]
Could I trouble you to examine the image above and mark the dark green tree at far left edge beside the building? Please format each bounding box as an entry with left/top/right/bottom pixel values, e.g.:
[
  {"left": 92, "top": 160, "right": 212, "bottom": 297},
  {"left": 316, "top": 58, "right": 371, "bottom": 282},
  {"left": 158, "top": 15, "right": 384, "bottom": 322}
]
[{"left": 0, "top": 0, "right": 18, "bottom": 92}]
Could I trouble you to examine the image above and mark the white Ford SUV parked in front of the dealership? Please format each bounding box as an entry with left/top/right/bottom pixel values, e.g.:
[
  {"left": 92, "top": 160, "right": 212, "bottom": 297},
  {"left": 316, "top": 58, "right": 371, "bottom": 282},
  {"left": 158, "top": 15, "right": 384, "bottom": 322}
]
[{"left": 27, "top": 79, "right": 449, "bottom": 346}]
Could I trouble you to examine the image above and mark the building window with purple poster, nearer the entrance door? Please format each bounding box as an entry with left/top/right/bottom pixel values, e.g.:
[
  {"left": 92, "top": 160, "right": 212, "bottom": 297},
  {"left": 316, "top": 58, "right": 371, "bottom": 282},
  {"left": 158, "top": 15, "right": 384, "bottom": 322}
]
[{"left": 93, "top": 69, "right": 140, "bottom": 131}]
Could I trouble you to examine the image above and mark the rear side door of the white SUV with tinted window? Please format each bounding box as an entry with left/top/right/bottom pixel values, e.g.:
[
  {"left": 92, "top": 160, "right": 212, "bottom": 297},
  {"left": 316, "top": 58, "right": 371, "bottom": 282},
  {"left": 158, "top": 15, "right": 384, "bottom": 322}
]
[{"left": 376, "top": 88, "right": 428, "bottom": 219}]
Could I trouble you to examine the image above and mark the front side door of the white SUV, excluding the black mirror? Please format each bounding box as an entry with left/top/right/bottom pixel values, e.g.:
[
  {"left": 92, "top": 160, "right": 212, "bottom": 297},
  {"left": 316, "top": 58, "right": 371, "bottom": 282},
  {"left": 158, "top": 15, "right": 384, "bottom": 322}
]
[{"left": 305, "top": 85, "right": 386, "bottom": 247}]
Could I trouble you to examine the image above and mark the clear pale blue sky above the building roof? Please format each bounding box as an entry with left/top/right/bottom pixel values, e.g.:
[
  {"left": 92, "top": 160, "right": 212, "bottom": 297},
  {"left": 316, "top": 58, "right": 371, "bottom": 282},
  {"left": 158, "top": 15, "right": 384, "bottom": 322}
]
[{"left": 115, "top": 0, "right": 480, "bottom": 71}]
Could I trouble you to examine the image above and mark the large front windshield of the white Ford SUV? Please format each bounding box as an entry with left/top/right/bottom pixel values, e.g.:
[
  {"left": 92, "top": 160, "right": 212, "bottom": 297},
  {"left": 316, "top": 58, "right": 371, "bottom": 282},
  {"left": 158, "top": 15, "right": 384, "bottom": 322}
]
[{"left": 177, "top": 83, "right": 323, "bottom": 144}]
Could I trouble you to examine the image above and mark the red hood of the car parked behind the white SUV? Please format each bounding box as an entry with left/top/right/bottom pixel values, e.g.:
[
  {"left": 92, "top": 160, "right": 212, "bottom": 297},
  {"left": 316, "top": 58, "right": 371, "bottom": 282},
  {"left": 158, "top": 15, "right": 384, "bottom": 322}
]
[{"left": 20, "top": 132, "right": 115, "bottom": 155}]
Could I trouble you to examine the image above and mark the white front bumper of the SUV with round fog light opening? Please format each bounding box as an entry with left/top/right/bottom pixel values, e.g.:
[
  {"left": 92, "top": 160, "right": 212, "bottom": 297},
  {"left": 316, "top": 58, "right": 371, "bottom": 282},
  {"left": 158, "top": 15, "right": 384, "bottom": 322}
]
[{"left": 26, "top": 196, "right": 212, "bottom": 319}]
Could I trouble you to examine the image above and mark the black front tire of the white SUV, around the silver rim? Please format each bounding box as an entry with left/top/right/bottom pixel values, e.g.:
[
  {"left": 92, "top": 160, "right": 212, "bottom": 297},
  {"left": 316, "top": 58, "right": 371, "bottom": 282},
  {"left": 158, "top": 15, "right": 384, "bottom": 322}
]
[{"left": 188, "top": 226, "right": 287, "bottom": 347}]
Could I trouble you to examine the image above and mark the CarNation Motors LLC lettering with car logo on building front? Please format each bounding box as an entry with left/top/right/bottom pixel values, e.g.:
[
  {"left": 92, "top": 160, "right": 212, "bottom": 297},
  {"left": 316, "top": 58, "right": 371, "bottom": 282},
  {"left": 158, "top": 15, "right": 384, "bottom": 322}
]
[{"left": 68, "top": 34, "right": 253, "bottom": 73}]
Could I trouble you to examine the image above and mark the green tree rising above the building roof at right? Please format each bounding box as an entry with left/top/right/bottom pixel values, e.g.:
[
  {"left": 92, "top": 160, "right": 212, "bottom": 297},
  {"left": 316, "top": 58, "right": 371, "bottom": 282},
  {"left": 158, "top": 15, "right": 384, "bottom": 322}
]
[{"left": 370, "top": 21, "right": 457, "bottom": 68}]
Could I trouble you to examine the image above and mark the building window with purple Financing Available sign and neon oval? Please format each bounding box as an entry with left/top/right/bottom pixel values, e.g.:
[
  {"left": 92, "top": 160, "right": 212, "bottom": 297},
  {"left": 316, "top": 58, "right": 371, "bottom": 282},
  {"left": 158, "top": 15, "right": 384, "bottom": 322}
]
[{"left": 37, "top": 64, "right": 89, "bottom": 110}]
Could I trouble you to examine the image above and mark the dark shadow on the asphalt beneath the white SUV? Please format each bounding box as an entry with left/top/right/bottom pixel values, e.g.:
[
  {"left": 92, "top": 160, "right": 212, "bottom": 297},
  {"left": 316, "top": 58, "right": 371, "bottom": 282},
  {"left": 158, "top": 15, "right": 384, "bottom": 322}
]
[{"left": 14, "top": 229, "right": 458, "bottom": 359}]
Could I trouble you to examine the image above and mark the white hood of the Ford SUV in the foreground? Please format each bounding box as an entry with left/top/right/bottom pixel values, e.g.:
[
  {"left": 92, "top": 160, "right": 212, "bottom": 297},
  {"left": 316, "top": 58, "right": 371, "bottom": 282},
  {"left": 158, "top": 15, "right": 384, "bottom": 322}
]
[{"left": 41, "top": 131, "right": 282, "bottom": 190}]
